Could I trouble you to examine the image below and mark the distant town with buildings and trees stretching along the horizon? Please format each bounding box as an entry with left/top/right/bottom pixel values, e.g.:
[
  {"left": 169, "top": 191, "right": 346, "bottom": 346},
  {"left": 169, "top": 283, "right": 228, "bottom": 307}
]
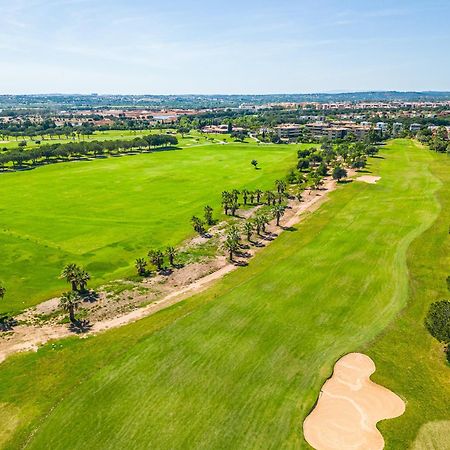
[{"left": 0, "top": 93, "right": 450, "bottom": 150}]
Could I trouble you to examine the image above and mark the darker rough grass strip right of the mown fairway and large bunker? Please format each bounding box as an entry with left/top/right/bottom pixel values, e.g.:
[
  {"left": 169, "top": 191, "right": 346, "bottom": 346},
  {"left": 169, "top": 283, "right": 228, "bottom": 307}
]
[{"left": 367, "top": 141, "right": 450, "bottom": 450}]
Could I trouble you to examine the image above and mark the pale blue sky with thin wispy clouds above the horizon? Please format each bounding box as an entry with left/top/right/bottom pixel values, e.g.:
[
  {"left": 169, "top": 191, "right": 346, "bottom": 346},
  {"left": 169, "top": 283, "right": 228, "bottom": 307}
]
[{"left": 0, "top": 0, "right": 450, "bottom": 94}]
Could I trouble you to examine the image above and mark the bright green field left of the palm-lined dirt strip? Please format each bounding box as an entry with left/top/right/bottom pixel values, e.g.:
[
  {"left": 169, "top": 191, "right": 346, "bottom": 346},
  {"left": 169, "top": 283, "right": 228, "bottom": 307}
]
[{"left": 0, "top": 143, "right": 297, "bottom": 312}]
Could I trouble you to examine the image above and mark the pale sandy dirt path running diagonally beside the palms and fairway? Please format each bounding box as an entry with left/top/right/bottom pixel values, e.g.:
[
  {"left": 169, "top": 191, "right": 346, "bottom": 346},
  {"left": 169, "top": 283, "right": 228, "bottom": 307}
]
[{"left": 0, "top": 174, "right": 348, "bottom": 363}]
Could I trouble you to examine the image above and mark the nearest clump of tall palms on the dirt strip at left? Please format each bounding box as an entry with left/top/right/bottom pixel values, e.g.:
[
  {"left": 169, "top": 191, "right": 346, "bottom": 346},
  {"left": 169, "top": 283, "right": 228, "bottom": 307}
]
[{"left": 59, "top": 263, "right": 91, "bottom": 325}]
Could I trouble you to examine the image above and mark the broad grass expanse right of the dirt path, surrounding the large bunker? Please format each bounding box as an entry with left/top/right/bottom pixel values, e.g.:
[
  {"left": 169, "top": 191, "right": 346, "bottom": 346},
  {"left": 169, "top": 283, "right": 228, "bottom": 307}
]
[{"left": 0, "top": 141, "right": 450, "bottom": 449}]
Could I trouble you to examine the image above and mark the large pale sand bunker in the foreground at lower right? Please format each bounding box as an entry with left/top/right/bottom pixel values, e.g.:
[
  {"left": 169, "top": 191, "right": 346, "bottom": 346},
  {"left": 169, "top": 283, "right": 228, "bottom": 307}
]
[{"left": 303, "top": 353, "right": 405, "bottom": 450}]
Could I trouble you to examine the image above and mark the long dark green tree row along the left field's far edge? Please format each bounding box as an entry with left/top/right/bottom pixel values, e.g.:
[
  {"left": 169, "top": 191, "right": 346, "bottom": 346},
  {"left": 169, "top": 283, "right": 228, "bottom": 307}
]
[{"left": 0, "top": 134, "right": 178, "bottom": 168}]
